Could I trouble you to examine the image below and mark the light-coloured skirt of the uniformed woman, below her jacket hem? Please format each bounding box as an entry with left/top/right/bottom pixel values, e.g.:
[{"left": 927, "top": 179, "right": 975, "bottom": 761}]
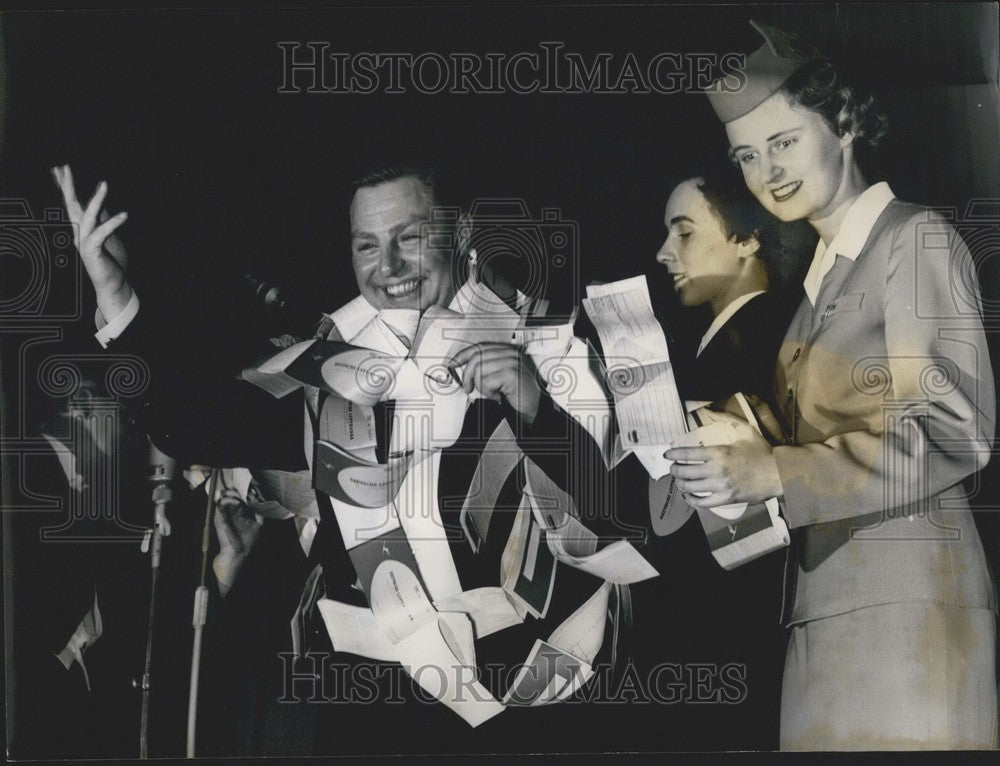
[{"left": 780, "top": 603, "right": 997, "bottom": 750}]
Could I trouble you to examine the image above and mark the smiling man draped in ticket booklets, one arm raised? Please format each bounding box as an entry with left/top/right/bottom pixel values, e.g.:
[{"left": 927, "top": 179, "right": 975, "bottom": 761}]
[{"left": 55, "top": 160, "right": 624, "bottom": 755}]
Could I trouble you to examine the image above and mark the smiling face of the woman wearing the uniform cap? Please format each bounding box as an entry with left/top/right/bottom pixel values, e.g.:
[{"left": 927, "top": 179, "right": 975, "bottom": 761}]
[{"left": 726, "top": 91, "right": 854, "bottom": 221}]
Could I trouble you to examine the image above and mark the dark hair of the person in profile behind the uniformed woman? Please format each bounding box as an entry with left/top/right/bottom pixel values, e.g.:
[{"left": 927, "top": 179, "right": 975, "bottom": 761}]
[{"left": 697, "top": 172, "right": 816, "bottom": 291}]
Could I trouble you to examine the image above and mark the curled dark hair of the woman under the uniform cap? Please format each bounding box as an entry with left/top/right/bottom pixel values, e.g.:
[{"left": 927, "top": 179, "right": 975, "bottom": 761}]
[{"left": 778, "top": 57, "right": 886, "bottom": 170}]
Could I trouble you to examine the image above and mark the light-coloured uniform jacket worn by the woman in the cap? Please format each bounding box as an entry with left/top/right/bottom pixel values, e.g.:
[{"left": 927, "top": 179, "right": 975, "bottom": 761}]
[{"left": 775, "top": 200, "right": 996, "bottom": 624}]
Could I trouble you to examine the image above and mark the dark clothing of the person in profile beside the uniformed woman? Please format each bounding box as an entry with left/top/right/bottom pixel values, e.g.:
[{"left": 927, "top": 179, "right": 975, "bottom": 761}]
[{"left": 633, "top": 293, "right": 797, "bottom": 750}]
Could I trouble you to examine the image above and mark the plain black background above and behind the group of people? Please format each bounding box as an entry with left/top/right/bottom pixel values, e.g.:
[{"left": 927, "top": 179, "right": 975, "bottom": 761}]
[{"left": 0, "top": 4, "right": 1000, "bottom": 760}]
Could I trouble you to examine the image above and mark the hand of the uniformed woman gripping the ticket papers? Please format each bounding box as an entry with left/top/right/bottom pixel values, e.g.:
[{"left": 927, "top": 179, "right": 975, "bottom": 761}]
[{"left": 664, "top": 422, "right": 783, "bottom": 508}]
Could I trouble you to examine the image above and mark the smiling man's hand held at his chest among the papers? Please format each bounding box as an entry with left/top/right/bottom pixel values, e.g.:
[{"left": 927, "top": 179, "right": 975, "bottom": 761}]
[{"left": 448, "top": 343, "right": 542, "bottom": 425}]
